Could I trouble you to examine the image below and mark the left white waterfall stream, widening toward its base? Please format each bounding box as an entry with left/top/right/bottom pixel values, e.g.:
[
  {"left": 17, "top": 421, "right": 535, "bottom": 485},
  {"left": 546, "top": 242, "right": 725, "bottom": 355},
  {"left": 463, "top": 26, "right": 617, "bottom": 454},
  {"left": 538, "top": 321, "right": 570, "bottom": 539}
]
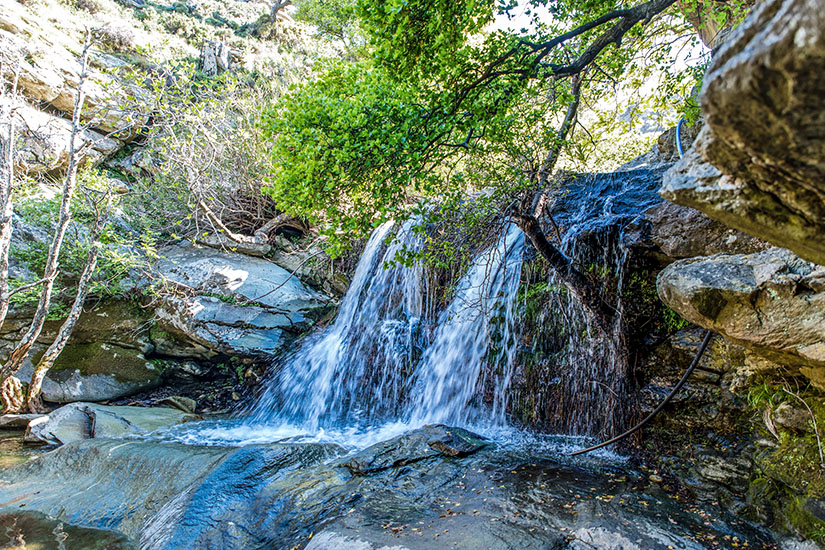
[{"left": 251, "top": 220, "right": 424, "bottom": 432}]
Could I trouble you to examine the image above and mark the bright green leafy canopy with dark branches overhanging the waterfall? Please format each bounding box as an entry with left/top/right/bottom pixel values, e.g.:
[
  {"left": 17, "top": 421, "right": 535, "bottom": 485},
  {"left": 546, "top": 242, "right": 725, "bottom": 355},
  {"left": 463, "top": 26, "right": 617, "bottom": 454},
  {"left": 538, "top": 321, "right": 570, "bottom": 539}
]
[{"left": 261, "top": 0, "right": 712, "bottom": 254}]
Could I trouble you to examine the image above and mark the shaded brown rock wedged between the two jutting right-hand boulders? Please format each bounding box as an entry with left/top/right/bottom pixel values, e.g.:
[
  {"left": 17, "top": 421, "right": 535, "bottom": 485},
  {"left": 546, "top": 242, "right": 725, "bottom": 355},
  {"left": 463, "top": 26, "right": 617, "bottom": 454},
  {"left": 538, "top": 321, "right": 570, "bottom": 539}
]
[{"left": 645, "top": 202, "right": 769, "bottom": 259}]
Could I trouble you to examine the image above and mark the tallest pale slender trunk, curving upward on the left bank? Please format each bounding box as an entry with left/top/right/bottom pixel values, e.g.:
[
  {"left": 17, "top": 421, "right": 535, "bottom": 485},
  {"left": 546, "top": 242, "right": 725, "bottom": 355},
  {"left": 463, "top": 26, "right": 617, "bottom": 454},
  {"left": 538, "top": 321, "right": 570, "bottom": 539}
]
[{"left": 0, "top": 30, "right": 91, "bottom": 406}]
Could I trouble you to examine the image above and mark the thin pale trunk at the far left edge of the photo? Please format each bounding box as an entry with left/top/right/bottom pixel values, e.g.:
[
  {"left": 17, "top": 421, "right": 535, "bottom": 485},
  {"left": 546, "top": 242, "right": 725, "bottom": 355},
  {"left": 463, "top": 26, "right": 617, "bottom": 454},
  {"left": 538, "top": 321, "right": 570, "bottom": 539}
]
[{"left": 0, "top": 66, "right": 18, "bottom": 328}]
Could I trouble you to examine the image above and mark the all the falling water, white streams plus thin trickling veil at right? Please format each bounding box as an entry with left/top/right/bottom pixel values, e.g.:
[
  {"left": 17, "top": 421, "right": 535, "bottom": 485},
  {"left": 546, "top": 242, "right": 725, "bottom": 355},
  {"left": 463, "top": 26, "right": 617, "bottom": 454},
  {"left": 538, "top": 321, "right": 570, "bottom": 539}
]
[{"left": 169, "top": 170, "right": 660, "bottom": 446}]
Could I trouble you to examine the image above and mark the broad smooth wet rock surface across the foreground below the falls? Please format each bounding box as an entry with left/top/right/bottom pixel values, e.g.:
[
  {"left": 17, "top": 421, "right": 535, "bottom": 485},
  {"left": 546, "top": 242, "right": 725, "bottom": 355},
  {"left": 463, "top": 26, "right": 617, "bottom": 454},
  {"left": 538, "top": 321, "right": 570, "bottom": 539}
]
[{"left": 0, "top": 427, "right": 773, "bottom": 550}]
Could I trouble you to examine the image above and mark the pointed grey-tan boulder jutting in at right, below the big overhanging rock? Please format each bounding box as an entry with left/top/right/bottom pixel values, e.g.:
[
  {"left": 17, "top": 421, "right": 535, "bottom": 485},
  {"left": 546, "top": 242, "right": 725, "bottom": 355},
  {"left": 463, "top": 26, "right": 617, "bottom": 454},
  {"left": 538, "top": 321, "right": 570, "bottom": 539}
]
[{"left": 657, "top": 248, "right": 825, "bottom": 388}]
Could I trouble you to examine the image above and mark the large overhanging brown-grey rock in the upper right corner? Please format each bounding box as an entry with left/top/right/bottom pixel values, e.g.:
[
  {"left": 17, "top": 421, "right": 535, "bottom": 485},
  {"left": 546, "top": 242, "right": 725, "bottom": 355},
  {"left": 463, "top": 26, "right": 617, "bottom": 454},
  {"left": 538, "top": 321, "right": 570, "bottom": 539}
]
[{"left": 661, "top": 0, "right": 825, "bottom": 264}]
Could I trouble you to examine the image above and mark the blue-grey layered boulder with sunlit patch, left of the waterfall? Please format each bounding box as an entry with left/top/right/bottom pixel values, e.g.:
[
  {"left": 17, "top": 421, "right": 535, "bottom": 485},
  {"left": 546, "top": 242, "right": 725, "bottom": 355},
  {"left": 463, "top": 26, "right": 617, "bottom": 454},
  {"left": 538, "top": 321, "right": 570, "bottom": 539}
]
[{"left": 155, "top": 246, "right": 330, "bottom": 357}]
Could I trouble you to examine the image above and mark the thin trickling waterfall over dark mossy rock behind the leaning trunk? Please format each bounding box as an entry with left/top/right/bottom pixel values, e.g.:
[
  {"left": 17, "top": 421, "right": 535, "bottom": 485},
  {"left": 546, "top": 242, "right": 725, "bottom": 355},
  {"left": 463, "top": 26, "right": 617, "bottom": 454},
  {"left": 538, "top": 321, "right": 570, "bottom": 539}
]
[{"left": 512, "top": 169, "right": 661, "bottom": 437}]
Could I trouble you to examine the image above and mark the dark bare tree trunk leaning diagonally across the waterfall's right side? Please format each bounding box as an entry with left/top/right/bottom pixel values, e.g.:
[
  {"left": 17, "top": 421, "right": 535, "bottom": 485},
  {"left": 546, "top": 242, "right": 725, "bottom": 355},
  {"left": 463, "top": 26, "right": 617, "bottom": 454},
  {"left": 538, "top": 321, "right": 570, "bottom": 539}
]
[{"left": 513, "top": 213, "right": 616, "bottom": 334}]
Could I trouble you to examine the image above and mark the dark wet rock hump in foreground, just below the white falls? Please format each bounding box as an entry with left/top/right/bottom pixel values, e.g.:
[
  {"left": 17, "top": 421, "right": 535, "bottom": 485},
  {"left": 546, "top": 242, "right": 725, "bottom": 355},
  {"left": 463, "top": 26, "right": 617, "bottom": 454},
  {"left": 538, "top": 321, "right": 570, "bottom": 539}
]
[{"left": 342, "top": 424, "right": 487, "bottom": 475}]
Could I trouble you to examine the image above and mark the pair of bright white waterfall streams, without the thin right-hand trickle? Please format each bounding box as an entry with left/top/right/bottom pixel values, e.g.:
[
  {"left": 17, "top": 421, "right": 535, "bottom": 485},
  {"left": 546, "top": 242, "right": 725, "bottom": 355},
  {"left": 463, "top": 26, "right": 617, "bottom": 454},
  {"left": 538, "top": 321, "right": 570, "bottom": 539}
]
[{"left": 249, "top": 220, "right": 524, "bottom": 440}]
